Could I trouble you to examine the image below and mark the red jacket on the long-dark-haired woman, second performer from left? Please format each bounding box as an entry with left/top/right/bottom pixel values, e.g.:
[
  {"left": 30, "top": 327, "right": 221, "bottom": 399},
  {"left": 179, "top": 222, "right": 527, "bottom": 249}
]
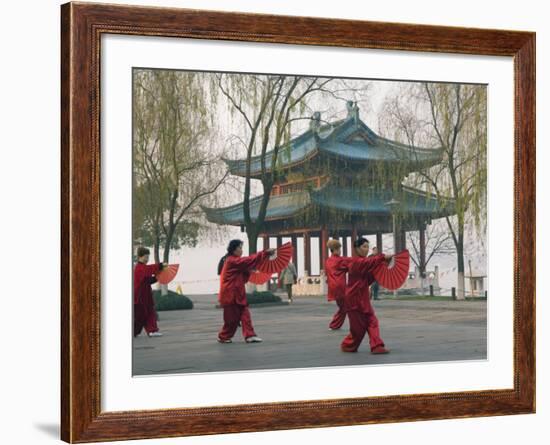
[{"left": 218, "top": 250, "right": 269, "bottom": 306}]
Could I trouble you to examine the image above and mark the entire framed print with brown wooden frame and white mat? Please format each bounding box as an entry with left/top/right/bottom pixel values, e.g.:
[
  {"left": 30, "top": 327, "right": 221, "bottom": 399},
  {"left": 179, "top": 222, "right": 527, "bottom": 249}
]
[{"left": 61, "top": 3, "right": 535, "bottom": 443}]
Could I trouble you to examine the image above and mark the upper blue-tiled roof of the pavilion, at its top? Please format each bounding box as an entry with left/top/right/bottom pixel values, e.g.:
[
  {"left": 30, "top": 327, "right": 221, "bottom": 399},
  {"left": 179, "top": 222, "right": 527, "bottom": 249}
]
[{"left": 224, "top": 114, "right": 443, "bottom": 176}]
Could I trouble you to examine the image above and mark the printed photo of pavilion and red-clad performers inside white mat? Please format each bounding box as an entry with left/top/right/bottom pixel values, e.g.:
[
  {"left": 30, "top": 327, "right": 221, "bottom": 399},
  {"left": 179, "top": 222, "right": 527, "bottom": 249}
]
[{"left": 132, "top": 66, "right": 490, "bottom": 376}]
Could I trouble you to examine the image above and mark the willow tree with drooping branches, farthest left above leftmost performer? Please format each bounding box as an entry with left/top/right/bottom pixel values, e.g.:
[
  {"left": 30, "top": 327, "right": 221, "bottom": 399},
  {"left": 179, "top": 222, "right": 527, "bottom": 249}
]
[{"left": 133, "top": 70, "right": 226, "bottom": 262}]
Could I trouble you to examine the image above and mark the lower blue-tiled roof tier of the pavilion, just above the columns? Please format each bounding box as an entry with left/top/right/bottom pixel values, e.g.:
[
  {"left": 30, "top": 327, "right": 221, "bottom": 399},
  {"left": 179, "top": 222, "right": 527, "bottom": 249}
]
[{"left": 203, "top": 184, "right": 454, "bottom": 225}]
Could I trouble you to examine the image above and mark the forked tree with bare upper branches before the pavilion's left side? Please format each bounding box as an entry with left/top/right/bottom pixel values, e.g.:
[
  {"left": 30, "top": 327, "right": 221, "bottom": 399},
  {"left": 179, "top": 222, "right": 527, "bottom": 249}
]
[{"left": 217, "top": 74, "right": 331, "bottom": 253}]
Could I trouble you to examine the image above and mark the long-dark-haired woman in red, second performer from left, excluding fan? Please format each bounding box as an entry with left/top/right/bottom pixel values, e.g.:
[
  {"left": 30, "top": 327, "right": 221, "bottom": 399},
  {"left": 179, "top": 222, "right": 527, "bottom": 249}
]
[{"left": 218, "top": 240, "right": 275, "bottom": 343}]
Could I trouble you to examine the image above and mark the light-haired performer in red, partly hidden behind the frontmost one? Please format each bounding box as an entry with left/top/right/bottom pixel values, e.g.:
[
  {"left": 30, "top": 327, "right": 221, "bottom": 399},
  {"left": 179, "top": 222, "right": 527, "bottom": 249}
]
[{"left": 325, "top": 239, "right": 349, "bottom": 331}]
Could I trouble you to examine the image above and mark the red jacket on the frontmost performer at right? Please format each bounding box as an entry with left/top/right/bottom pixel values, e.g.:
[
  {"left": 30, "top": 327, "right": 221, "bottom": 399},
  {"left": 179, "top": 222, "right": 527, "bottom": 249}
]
[{"left": 344, "top": 253, "right": 384, "bottom": 312}]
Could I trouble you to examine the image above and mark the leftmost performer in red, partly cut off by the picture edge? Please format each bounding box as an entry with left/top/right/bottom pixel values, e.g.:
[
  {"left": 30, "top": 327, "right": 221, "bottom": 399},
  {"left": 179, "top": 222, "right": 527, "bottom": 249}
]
[{"left": 134, "top": 247, "right": 164, "bottom": 337}]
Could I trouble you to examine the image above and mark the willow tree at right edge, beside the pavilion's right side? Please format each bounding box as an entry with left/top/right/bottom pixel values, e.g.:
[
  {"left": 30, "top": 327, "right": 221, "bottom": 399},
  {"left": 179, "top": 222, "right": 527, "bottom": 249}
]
[{"left": 384, "top": 82, "right": 487, "bottom": 299}]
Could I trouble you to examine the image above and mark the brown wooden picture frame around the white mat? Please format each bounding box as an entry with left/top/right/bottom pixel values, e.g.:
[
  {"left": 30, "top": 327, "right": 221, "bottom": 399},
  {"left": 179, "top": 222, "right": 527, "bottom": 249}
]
[{"left": 61, "top": 3, "right": 535, "bottom": 443}]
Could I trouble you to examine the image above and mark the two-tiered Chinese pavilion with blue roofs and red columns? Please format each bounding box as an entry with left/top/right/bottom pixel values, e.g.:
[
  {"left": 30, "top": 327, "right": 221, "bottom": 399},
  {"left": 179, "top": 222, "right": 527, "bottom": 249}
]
[{"left": 203, "top": 101, "right": 454, "bottom": 273}]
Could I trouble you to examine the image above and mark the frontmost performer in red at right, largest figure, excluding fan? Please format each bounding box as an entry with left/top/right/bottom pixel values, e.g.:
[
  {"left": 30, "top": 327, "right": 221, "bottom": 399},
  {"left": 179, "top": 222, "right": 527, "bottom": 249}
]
[{"left": 341, "top": 238, "right": 393, "bottom": 354}]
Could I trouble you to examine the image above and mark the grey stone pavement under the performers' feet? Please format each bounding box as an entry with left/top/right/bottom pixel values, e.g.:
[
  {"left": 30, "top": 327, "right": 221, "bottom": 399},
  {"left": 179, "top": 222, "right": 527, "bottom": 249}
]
[{"left": 133, "top": 295, "right": 487, "bottom": 375}]
